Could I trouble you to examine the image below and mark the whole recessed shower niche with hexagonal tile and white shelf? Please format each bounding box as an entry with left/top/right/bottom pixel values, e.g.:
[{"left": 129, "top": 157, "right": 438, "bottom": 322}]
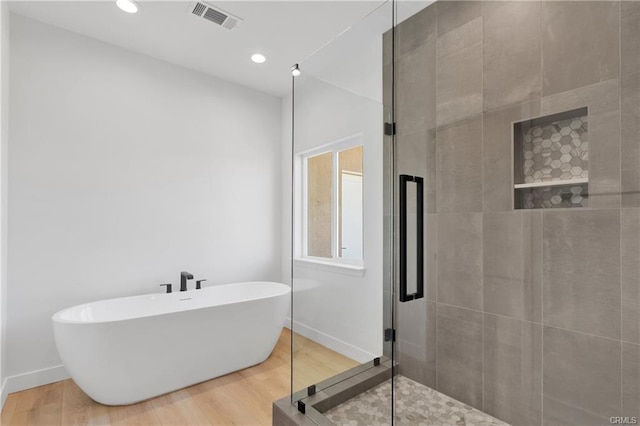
[{"left": 513, "top": 108, "right": 589, "bottom": 209}]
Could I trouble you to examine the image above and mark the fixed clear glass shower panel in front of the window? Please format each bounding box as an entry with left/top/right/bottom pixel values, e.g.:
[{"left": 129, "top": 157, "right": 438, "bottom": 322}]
[{"left": 292, "top": 2, "right": 393, "bottom": 423}]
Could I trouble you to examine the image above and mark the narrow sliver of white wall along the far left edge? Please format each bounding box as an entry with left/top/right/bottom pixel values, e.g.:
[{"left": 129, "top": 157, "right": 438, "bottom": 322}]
[{"left": 0, "top": 0, "right": 9, "bottom": 409}]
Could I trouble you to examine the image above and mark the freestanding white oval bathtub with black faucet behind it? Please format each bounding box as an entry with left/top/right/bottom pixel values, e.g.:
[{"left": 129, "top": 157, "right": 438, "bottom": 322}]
[{"left": 52, "top": 282, "right": 290, "bottom": 405}]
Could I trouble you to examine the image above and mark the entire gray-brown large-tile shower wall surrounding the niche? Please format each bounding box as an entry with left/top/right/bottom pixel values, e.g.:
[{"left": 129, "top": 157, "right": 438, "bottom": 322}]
[{"left": 385, "top": 0, "right": 640, "bottom": 425}]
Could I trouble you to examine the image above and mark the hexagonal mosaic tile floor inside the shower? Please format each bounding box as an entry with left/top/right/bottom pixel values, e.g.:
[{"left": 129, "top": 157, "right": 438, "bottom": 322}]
[{"left": 324, "top": 376, "right": 508, "bottom": 426}]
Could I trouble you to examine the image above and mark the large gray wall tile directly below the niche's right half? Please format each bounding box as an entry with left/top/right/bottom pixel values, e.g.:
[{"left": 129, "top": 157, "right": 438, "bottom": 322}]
[{"left": 542, "top": 210, "right": 621, "bottom": 340}]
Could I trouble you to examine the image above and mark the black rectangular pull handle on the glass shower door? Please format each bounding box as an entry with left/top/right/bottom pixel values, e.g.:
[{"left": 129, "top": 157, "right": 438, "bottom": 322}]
[{"left": 399, "top": 175, "right": 424, "bottom": 302}]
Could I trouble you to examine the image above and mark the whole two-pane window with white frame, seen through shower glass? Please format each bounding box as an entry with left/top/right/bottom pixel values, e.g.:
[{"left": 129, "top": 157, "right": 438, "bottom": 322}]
[{"left": 302, "top": 137, "right": 363, "bottom": 264}]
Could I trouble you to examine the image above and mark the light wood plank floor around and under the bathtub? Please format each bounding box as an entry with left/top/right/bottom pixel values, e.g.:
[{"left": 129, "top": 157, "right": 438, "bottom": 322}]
[{"left": 0, "top": 329, "right": 357, "bottom": 426}]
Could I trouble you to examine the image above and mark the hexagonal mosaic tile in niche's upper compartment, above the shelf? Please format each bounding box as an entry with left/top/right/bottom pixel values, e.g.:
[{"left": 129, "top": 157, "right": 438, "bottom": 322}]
[{"left": 519, "top": 115, "right": 589, "bottom": 183}]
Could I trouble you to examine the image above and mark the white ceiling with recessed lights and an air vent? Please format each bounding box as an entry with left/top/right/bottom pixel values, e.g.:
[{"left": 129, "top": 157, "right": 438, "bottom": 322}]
[{"left": 9, "top": 1, "right": 390, "bottom": 96}]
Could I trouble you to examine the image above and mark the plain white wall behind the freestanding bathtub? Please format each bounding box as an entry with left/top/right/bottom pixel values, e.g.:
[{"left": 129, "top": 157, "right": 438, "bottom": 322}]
[{"left": 7, "top": 15, "right": 282, "bottom": 391}]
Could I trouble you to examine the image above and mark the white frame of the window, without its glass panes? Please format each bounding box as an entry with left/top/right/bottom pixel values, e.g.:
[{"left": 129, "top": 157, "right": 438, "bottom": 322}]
[{"left": 297, "top": 133, "right": 366, "bottom": 269}]
